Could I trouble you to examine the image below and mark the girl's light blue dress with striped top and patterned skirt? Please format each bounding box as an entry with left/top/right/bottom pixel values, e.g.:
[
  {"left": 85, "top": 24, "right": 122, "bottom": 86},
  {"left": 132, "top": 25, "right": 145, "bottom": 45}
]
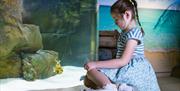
[{"left": 99, "top": 27, "right": 160, "bottom": 91}]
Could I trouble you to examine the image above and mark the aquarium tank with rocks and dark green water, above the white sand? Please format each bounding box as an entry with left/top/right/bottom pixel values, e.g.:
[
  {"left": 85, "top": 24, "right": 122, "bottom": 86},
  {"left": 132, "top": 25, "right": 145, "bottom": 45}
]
[{"left": 0, "top": 0, "right": 98, "bottom": 81}]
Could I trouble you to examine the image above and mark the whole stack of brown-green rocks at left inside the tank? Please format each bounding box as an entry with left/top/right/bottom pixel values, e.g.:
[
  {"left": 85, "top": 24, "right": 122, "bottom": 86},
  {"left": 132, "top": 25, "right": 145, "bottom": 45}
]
[{"left": 0, "top": 0, "right": 62, "bottom": 80}]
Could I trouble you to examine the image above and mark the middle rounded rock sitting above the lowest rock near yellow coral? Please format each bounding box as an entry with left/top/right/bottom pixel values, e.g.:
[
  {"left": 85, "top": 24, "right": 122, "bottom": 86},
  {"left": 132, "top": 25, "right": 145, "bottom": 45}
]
[{"left": 15, "top": 24, "right": 43, "bottom": 52}]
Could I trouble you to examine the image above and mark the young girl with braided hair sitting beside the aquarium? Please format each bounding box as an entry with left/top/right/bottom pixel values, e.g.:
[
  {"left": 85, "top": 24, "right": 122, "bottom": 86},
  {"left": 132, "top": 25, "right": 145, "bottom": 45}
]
[{"left": 84, "top": 0, "right": 160, "bottom": 91}]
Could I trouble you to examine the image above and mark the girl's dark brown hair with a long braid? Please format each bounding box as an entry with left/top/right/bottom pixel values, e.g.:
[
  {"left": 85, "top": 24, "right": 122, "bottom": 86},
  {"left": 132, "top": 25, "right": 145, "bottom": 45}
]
[{"left": 111, "top": 0, "right": 144, "bottom": 35}]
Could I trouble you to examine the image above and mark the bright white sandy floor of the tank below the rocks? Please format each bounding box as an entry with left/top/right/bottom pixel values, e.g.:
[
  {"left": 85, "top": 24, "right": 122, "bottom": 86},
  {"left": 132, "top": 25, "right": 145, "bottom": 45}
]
[{"left": 0, "top": 66, "right": 86, "bottom": 91}]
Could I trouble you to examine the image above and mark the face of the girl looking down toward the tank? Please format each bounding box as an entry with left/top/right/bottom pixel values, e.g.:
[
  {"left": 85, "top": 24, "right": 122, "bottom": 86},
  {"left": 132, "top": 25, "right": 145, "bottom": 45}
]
[{"left": 111, "top": 12, "right": 131, "bottom": 30}]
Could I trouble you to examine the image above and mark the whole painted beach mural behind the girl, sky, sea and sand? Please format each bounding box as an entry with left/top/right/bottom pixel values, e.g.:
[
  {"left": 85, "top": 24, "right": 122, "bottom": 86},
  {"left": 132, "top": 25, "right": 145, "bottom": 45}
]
[{"left": 97, "top": 0, "right": 180, "bottom": 73}]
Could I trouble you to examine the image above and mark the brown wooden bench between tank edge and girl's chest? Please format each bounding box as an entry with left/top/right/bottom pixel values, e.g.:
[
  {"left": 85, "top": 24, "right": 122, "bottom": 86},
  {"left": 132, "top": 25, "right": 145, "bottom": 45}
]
[{"left": 99, "top": 30, "right": 120, "bottom": 60}]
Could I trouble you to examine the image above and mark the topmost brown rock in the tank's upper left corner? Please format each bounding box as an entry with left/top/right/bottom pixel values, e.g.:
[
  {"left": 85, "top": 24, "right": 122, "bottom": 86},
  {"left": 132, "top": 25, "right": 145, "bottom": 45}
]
[{"left": 0, "top": 0, "right": 23, "bottom": 26}]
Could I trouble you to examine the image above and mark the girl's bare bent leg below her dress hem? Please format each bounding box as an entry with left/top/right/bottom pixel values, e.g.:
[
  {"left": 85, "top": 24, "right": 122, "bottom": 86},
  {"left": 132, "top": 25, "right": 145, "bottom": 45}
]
[{"left": 87, "top": 69, "right": 111, "bottom": 88}]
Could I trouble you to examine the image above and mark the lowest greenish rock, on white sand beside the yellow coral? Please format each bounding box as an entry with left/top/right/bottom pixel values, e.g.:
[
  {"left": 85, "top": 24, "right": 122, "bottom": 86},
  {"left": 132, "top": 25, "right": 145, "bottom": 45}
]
[{"left": 22, "top": 50, "right": 58, "bottom": 80}]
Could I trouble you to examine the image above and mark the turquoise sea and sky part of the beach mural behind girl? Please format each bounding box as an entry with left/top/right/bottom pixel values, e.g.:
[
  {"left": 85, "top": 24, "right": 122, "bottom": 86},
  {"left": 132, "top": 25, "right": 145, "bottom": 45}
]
[{"left": 97, "top": 5, "right": 180, "bottom": 51}]
